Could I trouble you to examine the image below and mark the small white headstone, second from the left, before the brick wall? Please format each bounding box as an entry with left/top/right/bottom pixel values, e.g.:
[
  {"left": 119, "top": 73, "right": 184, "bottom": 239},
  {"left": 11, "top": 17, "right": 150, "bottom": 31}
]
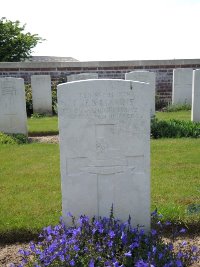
[{"left": 31, "top": 75, "right": 52, "bottom": 115}]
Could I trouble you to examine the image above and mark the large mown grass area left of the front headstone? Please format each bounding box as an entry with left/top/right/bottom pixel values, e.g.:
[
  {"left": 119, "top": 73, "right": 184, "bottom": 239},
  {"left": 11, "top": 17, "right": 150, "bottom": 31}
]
[{"left": 0, "top": 144, "right": 61, "bottom": 243}]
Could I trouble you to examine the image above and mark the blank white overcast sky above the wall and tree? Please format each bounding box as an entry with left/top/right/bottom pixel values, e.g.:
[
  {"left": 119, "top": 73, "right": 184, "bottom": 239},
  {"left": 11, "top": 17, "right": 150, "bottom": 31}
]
[{"left": 0, "top": 0, "right": 200, "bottom": 61}]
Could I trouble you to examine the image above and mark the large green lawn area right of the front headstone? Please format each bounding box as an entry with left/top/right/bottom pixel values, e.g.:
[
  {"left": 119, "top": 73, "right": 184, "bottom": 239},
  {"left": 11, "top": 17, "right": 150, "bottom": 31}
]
[{"left": 151, "top": 138, "right": 200, "bottom": 223}]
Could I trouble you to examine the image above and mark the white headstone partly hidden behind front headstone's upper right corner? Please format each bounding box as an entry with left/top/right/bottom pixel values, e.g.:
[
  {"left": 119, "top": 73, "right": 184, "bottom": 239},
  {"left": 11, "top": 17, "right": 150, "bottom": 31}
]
[{"left": 125, "top": 71, "right": 156, "bottom": 116}]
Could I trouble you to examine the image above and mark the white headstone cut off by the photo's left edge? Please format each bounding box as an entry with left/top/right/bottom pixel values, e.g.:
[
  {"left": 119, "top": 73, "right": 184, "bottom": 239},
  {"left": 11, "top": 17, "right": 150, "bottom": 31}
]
[{"left": 0, "top": 77, "right": 27, "bottom": 134}]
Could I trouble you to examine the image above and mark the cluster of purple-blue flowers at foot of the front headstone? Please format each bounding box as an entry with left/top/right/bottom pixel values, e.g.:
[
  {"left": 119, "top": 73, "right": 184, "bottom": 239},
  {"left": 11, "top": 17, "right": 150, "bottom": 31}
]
[{"left": 13, "top": 212, "right": 199, "bottom": 267}]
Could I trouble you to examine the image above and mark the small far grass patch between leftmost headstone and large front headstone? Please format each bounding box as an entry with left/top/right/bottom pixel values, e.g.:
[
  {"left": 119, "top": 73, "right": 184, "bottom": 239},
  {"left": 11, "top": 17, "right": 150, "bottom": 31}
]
[{"left": 28, "top": 116, "right": 58, "bottom": 136}]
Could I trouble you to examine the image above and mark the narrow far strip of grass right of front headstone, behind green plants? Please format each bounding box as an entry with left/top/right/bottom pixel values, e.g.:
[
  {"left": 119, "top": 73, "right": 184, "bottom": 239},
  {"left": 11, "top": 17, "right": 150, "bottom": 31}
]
[{"left": 156, "top": 110, "right": 191, "bottom": 121}]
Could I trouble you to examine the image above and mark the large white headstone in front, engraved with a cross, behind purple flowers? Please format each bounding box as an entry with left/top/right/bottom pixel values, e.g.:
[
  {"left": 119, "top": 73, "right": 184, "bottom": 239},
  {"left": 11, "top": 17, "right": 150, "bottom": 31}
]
[{"left": 58, "top": 80, "right": 151, "bottom": 229}]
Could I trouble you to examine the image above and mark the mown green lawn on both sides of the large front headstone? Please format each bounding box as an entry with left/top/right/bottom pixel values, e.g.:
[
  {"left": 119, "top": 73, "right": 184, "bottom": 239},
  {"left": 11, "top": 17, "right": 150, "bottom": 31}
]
[{"left": 0, "top": 138, "right": 200, "bottom": 242}]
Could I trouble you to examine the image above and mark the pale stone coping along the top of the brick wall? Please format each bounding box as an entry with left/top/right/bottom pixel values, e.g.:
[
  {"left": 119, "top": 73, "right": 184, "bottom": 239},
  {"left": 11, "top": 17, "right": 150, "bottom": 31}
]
[{"left": 0, "top": 59, "right": 200, "bottom": 70}]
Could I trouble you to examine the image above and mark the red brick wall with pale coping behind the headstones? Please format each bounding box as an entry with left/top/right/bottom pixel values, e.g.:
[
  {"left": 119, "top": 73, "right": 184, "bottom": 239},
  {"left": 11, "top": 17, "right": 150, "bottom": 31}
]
[{"left": 0, "top": 59, "right": 200, "bottom": 101}]
